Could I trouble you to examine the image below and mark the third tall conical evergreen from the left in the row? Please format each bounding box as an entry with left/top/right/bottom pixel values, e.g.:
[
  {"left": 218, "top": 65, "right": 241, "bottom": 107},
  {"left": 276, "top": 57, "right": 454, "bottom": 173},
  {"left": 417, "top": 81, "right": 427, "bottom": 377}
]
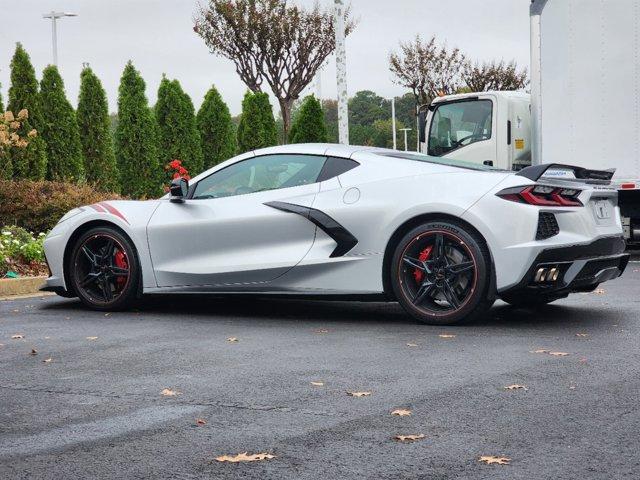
[{"left": 77, "top": 67, "right": 120, "bottom": 192}]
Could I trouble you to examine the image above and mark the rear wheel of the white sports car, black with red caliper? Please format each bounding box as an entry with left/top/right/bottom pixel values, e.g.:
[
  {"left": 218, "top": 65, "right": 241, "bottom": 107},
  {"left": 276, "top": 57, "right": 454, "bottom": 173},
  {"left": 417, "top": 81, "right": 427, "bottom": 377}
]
[{"left": 391, "top": 221, "right": 495, "bottom": 325}]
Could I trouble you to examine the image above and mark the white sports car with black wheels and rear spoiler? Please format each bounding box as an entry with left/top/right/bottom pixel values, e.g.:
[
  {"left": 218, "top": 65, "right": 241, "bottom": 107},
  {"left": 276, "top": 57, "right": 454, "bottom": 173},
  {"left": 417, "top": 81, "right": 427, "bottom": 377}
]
[{"left": 43, "top": 144, "right": 629, "bottom": 324}]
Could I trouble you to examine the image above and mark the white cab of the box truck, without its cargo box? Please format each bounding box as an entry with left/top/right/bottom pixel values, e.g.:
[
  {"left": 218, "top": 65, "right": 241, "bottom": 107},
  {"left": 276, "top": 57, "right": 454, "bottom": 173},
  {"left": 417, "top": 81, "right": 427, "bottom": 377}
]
[{"left": 419, "top": 91, "right": 531, "bottom": 170}]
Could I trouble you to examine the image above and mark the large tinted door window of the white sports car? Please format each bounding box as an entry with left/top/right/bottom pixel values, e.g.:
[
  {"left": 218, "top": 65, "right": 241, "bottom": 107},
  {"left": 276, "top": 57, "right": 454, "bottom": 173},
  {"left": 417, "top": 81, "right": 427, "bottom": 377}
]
[{"left": 192, "top": 154, "right": 326, "bottom": 199}]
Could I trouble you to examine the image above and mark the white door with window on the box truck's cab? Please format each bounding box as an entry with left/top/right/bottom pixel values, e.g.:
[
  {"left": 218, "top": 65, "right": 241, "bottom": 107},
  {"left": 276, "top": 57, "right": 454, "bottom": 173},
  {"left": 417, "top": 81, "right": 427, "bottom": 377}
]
[{"left": 427, "top": 98, "right": 499, "bottom": 167}]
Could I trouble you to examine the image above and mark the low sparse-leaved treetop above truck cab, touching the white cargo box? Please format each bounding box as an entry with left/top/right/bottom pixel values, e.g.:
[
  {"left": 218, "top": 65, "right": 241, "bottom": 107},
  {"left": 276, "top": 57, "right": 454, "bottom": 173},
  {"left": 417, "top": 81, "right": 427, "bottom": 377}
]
[{"left": 462, "top": 60, "right": 529, "bottom": 92}]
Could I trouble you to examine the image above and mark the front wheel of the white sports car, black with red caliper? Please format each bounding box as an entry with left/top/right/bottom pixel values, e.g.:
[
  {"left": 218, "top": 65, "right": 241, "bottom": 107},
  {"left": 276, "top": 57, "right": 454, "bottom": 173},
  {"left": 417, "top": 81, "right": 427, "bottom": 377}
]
[{"left": 67, "top": 227, "right": 140, "bottom": 311}]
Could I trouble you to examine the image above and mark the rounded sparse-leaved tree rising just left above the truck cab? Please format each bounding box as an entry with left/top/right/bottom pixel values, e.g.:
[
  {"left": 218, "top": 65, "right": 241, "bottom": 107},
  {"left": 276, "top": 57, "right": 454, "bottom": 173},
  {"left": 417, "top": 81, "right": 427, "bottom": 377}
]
[{"left": 389, "top": 35, "right": 466, "bottom": 109}]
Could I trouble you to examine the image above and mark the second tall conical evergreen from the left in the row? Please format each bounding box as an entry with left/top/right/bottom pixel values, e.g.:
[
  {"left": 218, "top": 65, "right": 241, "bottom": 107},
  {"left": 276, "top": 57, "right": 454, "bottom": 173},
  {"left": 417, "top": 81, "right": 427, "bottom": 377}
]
[{"left": 40, "top": 65, "right": 84, "bottom": 182}]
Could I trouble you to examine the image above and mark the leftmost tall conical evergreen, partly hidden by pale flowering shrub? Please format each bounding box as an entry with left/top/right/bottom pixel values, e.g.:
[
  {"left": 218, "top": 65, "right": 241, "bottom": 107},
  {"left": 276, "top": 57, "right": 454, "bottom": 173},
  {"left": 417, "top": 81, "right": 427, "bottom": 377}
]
[{"left": 7, "top": 43, "right": 47, "bottom": 180}]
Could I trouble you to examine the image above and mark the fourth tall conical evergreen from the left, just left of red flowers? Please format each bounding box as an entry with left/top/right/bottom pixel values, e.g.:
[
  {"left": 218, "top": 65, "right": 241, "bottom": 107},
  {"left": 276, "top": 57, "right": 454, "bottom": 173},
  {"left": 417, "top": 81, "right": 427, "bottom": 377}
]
[{"left": 116, "top": 61, "right": 162, "bottom": 198}]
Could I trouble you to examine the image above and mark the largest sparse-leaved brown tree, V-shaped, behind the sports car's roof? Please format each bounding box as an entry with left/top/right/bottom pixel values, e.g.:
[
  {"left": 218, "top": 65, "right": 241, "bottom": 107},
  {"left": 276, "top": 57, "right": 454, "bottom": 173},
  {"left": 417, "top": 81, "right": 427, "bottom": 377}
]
[{"left": 194, "top": 0, "right": 355, "bottom": 140}]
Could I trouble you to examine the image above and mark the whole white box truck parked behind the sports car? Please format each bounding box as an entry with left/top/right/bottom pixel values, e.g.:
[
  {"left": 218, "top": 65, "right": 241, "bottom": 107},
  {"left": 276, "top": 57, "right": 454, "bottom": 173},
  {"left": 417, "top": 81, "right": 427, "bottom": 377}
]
[{"left": 419, "top": 0, "right": 640, "bottom": 243}]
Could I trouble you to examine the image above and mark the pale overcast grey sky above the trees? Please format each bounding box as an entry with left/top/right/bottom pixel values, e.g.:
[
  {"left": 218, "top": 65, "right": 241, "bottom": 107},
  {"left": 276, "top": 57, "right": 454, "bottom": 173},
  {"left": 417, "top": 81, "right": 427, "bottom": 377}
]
[{"left": 0, "top": 0, "right": 530, "bottom": 115}]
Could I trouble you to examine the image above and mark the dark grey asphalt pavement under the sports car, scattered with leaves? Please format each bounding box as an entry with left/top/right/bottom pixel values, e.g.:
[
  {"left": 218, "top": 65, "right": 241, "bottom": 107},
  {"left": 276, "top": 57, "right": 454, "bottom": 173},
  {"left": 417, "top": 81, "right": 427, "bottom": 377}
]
[{"left": 0, "top": 261, "right": 640, "bottom": 480}]
